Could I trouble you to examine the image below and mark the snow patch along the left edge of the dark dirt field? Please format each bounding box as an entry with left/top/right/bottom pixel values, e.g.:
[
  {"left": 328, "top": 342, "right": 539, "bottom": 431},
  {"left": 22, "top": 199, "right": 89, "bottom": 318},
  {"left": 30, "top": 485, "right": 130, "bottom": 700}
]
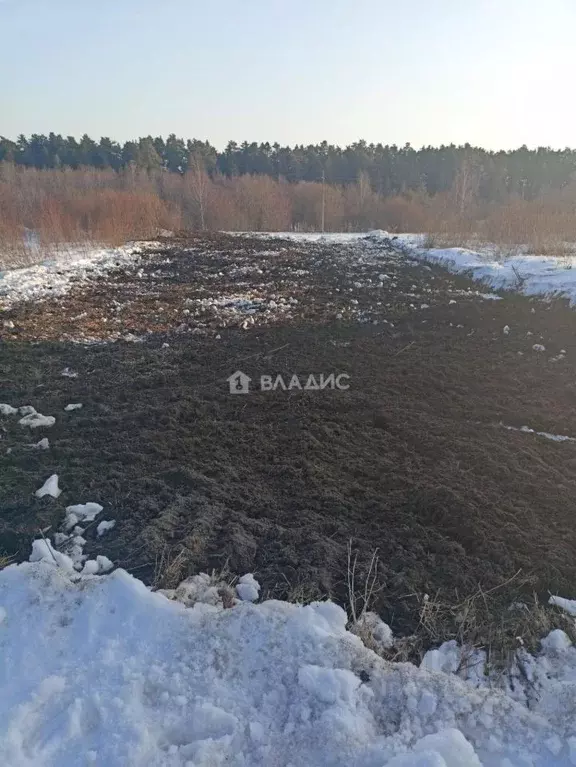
[{"left": 0, "top": 242, "right": 157, "bottom": 309}]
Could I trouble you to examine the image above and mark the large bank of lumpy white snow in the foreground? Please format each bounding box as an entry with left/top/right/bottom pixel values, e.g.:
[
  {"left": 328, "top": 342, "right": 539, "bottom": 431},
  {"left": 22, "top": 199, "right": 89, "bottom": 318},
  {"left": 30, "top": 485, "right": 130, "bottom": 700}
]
[{"left": 0, "top": 560, "right": 576, "bottom": 767}]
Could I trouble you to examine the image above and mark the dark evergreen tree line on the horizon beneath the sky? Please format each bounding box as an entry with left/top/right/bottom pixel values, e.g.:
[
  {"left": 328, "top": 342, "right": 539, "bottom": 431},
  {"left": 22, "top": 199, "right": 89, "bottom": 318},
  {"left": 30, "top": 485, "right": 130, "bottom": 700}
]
[{"left": 0, "top": 133, "right": 576, "bottom": 204}]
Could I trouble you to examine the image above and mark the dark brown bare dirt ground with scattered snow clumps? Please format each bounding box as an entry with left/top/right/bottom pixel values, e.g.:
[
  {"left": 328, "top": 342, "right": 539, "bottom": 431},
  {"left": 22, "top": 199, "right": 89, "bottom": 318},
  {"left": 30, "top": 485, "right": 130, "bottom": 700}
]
[{"left": 0, "top": 235, "right": 576, "bottom": 648}]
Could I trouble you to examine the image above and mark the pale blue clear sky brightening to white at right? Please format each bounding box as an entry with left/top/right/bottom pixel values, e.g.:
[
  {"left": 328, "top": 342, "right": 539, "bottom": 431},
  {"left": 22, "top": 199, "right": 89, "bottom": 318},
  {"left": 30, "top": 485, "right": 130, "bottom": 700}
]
[{"left": 0, "top": 0, "right": 576, "bottom": 149}]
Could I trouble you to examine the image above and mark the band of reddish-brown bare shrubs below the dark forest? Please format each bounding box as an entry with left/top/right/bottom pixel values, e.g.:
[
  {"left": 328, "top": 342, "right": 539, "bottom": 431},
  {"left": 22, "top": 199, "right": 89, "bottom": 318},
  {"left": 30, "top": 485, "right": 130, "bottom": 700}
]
[{"left": 0, "top": 161, "right": 576, "bottom": 267}]
